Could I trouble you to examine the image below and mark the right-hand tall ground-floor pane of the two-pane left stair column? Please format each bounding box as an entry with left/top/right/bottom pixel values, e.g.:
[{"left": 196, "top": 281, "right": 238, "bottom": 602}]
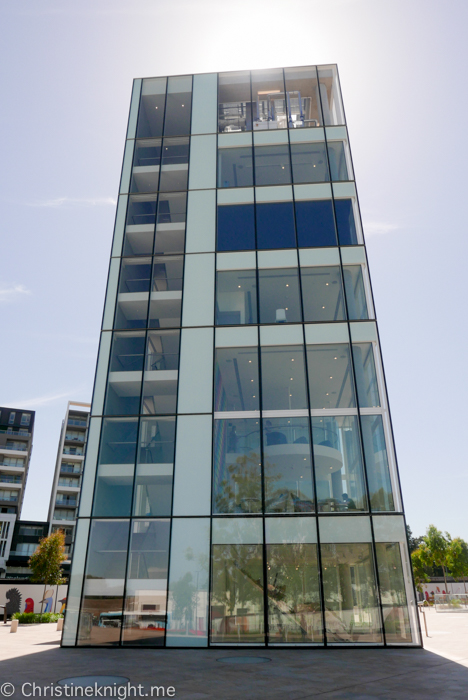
[{"left": 122, "top": 520, "right": 170, "bottom": 646}]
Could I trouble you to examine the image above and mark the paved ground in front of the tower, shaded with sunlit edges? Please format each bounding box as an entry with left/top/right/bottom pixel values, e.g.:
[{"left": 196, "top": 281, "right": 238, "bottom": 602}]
[{"left": 0, "top": 610, "right": 468, "bottom": 700}]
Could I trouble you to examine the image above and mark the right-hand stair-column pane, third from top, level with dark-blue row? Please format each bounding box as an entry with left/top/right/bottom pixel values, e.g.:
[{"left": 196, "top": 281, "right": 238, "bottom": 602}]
[{"left": 154, "top": 192, "right": 187, "bottom": 255}]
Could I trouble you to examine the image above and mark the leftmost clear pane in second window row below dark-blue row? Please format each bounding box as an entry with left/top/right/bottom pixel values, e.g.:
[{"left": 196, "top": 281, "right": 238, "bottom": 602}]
[{"left": 214, "top": 348, "right": 260, "bottom": 411}]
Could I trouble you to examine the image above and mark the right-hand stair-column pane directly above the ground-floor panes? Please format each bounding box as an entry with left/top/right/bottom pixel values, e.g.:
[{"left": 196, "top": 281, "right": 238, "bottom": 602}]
[{"left": 133, "top": 417, "right": 175, "bottom": 516}]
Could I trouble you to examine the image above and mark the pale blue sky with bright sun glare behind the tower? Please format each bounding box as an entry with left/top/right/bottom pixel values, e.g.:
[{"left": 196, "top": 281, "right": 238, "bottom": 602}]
[{"left": 0, "top": 0, "right": 468, "bottom": 539}]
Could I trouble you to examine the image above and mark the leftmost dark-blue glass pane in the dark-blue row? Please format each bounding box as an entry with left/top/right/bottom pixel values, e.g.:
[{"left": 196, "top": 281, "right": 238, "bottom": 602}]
[{"left": 217, "top": 204, "right": 255, "bottom": 251}]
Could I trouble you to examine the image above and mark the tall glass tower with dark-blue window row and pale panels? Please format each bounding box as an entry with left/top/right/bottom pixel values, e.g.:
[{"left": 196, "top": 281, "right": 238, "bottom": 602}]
[{"left": 62, "top": 65, "right": 420, "bottom": 647}]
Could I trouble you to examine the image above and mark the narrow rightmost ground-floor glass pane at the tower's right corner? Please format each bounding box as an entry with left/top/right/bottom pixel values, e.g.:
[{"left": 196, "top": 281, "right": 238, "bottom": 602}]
[{"left": 375, "top": 542, "right": 413, "bottom": 644}]
